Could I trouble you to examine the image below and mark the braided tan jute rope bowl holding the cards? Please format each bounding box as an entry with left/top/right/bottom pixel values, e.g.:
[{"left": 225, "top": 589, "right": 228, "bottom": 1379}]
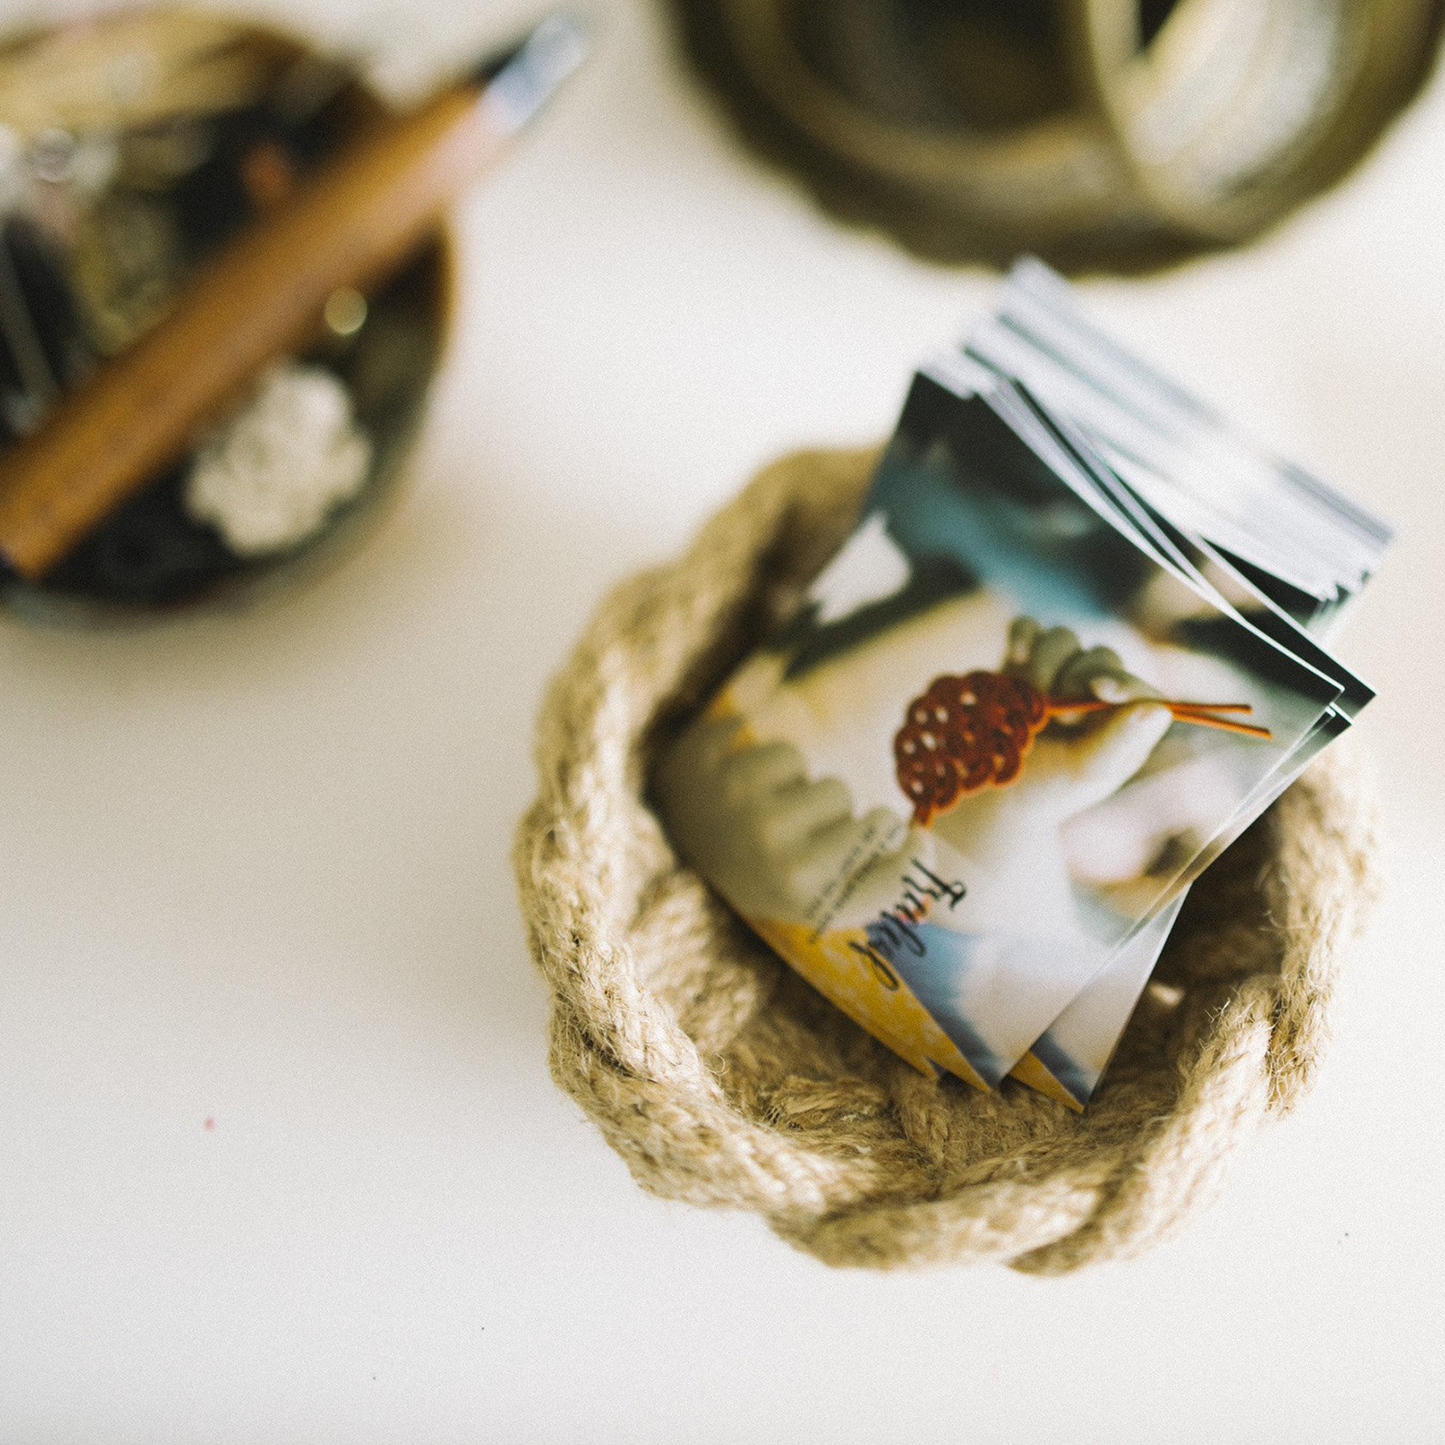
[{"left": 516, "top": 452, "right": 1374, "bottom": 1273}]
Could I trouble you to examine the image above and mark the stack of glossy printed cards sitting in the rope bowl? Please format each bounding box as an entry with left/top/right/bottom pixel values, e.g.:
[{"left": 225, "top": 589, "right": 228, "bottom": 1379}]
[{"left": 655, "top": 262, "right": 1390, "bottom": 1108}]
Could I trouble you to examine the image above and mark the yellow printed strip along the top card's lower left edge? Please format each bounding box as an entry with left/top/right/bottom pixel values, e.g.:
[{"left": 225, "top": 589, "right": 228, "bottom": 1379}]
[{"left": 749, "top": 919, "right": 988, "bottom": 1090}]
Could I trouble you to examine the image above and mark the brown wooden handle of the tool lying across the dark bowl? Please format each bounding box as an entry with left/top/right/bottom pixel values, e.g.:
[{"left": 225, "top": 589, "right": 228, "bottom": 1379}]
[{"left": 0, "top": 85, "right": 506, "bottom": 579}]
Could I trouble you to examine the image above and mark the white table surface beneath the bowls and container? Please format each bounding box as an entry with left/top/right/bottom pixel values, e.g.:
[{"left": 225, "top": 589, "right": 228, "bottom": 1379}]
[{"left": 0, "top": 0, "right": 1445, "bottom": 1445}]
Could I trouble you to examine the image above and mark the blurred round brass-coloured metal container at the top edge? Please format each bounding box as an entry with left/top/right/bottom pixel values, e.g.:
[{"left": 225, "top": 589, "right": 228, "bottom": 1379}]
[{"left": 668, "top": 0, "right": 1445, "bottom": 270}]
